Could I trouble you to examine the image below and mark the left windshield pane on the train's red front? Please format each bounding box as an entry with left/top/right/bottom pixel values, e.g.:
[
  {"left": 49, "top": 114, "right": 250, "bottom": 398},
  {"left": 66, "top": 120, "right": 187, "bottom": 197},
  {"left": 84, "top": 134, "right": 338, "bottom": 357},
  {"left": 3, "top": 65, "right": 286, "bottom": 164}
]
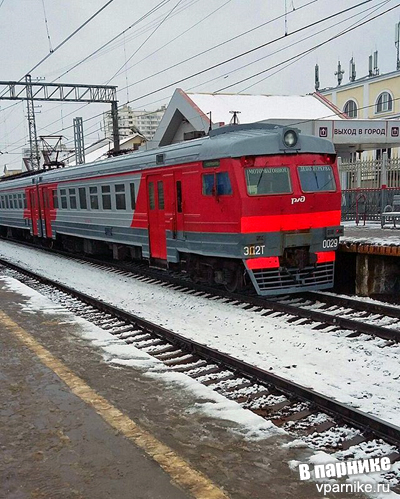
[{"left": 246, "top": 166, "right": 292, "bottom": 196}]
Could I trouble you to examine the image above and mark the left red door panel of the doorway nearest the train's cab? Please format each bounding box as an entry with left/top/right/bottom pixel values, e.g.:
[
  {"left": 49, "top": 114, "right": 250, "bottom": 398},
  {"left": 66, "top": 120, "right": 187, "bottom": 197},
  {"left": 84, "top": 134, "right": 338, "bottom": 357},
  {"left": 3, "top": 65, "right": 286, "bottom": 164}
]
[{"left": 147, "top": 175, "right": 167, "bottom": 260}]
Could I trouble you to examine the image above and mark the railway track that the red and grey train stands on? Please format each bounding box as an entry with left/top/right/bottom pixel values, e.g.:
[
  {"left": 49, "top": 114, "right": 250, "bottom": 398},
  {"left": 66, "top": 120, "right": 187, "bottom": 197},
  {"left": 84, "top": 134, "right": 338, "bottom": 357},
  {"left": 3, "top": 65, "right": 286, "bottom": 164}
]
[{"left": 0, "top": 237, "right": 400, "bottom": 345}]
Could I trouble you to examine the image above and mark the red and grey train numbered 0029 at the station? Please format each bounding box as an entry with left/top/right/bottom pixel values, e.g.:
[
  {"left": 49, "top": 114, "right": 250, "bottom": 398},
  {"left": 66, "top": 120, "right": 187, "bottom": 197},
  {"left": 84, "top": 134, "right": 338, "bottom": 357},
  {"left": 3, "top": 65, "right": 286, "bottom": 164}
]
[{"left": 0, "top": 124, "right": 343, "bottom": 295}]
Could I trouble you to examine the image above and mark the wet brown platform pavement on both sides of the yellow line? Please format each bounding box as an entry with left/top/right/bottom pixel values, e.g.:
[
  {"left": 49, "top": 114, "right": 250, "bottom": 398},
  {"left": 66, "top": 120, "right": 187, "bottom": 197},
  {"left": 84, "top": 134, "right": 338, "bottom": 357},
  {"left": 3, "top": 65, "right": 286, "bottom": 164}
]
[{"left": 0, "top": 275, "right": 366, "bottom": 499}]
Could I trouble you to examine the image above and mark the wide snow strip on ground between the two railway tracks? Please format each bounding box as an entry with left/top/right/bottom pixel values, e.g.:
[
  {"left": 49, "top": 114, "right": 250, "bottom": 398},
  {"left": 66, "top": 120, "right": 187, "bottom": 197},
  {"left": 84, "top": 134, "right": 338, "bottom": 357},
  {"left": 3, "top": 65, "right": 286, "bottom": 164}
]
[{"left": 0, "top": 241, "right": 400, "bottom": 426}]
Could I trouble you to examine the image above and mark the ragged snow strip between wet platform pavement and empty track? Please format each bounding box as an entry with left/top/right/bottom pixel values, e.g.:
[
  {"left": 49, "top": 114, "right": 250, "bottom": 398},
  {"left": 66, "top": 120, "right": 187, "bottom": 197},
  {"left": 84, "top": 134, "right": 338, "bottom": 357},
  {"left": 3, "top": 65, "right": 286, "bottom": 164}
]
[{"left": 0, "top": 276, "right": 280, "bottom": 440}]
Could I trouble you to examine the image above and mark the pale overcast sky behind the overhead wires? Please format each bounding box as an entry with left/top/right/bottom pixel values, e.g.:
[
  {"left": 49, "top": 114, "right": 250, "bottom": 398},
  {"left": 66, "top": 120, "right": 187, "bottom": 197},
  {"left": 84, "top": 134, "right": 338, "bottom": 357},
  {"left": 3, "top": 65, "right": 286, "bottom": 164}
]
[{"left": 0, "top": 0, "right": 400, "bottom": 171}]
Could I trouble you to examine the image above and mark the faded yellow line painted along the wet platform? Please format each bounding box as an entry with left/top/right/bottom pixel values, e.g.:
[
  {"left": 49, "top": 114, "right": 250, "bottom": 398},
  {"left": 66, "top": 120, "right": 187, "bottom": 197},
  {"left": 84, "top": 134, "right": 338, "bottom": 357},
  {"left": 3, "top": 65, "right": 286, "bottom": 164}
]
[{"left": 0, "top": 311, "right": 228, "bottom": 499}]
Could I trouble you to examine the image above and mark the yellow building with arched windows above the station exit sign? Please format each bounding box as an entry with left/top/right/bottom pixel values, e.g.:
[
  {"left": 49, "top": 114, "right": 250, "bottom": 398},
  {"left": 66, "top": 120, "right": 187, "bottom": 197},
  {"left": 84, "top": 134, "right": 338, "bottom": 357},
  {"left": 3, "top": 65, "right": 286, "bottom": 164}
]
[{"left": 319, "top": 70, "right": 400, "bottom": 159}]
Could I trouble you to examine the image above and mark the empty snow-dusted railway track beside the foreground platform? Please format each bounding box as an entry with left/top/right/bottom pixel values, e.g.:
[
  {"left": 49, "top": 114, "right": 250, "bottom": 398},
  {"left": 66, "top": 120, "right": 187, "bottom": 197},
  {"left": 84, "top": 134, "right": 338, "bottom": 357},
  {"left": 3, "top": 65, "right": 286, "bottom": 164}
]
[{"left": 0, "top": 260, "right": 400, "bottom": 492}]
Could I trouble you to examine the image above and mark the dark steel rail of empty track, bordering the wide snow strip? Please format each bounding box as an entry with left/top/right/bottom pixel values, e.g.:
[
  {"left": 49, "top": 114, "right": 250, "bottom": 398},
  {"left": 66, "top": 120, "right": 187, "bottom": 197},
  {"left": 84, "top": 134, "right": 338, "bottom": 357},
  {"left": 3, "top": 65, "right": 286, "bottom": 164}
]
[{"left": 0, "top": 258, "right": 400, "bottom": 447}]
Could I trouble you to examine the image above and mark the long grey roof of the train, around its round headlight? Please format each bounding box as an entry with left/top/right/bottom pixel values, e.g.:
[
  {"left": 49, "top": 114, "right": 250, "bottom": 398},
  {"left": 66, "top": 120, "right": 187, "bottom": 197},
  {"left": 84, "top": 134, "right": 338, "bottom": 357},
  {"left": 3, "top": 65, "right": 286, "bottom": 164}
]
[{"left": 4, "top": 123, "right": 336, "bottom": 187}]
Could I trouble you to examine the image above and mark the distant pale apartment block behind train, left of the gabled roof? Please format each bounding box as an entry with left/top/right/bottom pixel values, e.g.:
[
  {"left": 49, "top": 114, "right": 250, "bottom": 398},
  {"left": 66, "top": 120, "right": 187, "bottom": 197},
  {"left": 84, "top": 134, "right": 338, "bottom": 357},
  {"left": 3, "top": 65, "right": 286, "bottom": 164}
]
[{"left": 103, "top": 104, "right": 166, "bottom": 140}]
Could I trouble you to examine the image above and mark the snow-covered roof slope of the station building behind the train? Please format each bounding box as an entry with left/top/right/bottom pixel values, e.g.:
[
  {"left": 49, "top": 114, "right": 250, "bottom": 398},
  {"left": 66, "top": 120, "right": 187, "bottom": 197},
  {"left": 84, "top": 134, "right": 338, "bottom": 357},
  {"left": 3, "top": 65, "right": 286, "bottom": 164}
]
[{"left": 187, "top": 93, "right": 337, "bottom": 124}]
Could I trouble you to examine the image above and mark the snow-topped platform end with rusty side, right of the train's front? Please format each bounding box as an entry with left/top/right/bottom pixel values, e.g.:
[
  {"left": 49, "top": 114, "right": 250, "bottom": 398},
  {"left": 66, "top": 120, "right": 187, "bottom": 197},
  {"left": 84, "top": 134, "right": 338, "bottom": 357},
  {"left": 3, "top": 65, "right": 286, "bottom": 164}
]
[{"left": 336, "top": 221, "right": 400, "bottom": 297}]
